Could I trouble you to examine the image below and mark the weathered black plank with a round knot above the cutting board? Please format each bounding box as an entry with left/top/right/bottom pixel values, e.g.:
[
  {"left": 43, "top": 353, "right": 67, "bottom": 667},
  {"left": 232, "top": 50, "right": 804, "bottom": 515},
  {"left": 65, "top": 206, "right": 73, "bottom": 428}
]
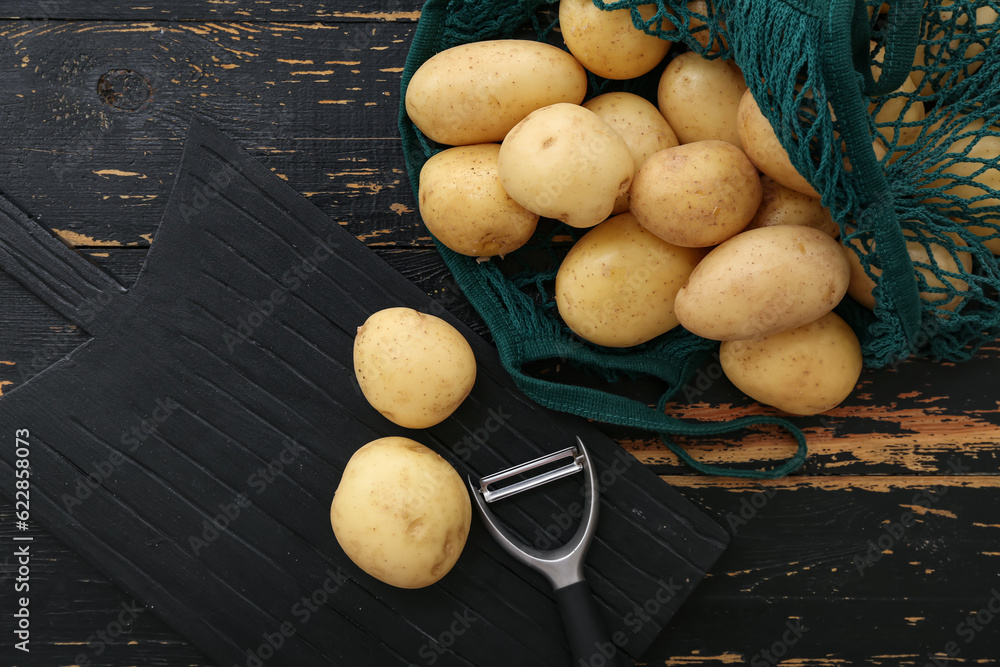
[{"left": 0, "top": 21, "right": 430, "bottom": 246}]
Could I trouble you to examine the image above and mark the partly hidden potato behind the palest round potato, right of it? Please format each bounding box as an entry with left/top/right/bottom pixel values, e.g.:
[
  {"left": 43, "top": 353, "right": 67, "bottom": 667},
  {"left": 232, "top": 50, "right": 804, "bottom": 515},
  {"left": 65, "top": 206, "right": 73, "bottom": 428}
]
[{"left": 583, "top": 93, "right": 679, "bottom": 214}]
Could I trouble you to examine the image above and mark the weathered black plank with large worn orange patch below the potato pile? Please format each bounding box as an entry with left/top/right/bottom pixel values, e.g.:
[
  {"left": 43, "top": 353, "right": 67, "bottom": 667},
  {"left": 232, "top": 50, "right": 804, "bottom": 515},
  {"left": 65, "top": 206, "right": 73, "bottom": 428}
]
[{"left": 0, "top": 247, "right": 1000, "bottom": 479}]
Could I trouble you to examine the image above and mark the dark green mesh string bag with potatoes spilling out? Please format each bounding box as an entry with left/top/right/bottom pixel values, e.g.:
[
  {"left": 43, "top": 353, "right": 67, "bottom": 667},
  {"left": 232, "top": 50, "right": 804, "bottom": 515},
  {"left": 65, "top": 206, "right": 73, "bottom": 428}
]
[{"left": 399, "top": 0, "right": 1000, "bottom": 478}]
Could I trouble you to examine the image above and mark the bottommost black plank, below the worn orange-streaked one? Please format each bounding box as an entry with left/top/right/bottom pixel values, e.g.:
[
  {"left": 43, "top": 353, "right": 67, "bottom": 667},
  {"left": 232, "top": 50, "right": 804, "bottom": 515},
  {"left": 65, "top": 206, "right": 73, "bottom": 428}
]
[{"left": 7, "top": 476, "right": 1000, "bottom": 667}]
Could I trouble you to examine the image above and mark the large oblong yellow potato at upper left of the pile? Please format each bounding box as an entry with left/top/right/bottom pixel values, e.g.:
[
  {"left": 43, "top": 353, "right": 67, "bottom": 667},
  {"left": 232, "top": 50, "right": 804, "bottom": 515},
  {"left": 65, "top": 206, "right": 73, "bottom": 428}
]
[{"left": 405, "top": 39, "right": 587, "bottom": 146}]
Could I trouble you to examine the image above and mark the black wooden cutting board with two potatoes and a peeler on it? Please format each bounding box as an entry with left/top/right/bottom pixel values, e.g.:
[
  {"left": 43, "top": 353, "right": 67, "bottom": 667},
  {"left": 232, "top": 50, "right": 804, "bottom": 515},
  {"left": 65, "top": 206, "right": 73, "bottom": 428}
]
[{"left": 0, "top": 120, "right": 728, "bottom": 667}]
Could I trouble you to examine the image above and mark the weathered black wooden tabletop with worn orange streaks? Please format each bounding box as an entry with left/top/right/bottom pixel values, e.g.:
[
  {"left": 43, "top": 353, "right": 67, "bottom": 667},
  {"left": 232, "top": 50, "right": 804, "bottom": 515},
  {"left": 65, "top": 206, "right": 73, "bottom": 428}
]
[{"left": 0, "top": 0, "right": 1000, "bottom": 667}]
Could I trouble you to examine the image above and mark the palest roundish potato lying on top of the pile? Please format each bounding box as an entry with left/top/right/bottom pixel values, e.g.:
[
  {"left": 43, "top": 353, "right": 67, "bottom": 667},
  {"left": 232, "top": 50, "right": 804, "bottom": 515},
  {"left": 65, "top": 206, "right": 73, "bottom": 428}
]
[{"left": 498, "top": 103, "right": 635, "bottom": 227}]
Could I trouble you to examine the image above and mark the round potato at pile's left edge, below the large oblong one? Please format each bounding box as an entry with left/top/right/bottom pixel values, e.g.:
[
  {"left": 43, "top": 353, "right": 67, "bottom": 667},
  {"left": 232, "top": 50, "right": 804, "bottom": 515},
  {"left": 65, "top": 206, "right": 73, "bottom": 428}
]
[{"left": 418, "top": 144, "right": 538, "bottom": 257}]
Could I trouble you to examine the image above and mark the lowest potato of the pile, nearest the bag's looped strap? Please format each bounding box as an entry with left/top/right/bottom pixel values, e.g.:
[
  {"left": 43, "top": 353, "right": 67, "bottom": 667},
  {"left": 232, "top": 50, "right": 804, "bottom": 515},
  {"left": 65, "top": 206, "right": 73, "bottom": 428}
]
[{"left": 719, "top": 313, "right": 863, "bottom": 415}]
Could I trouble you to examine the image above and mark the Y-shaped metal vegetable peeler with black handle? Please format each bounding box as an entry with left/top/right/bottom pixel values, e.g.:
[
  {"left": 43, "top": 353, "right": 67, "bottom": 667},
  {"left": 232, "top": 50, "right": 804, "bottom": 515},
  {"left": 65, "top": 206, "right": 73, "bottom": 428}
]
[{"left": 469, "top": 436, "right": 626, "bottom": 667}]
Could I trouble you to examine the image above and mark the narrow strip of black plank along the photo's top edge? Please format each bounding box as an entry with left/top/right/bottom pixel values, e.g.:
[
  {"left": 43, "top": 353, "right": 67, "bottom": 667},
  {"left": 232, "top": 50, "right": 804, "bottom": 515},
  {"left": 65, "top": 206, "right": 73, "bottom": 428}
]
[{"left": 0, "top": 0, "right": 423, "bottom": 22}]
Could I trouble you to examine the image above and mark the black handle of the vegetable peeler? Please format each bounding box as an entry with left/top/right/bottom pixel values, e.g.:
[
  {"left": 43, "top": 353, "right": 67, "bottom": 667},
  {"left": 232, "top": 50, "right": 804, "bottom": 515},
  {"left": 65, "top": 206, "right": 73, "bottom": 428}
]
[{"left": 555, "top": 581, "right": 631, "bottom": 667}]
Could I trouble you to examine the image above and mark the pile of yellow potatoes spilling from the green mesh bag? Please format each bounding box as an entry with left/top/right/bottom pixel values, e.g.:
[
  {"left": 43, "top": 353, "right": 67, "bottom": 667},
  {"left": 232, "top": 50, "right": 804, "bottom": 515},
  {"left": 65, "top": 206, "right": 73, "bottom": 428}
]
[{"left": 405, "top": 0, "right": 1000, "bottom": 415}]
